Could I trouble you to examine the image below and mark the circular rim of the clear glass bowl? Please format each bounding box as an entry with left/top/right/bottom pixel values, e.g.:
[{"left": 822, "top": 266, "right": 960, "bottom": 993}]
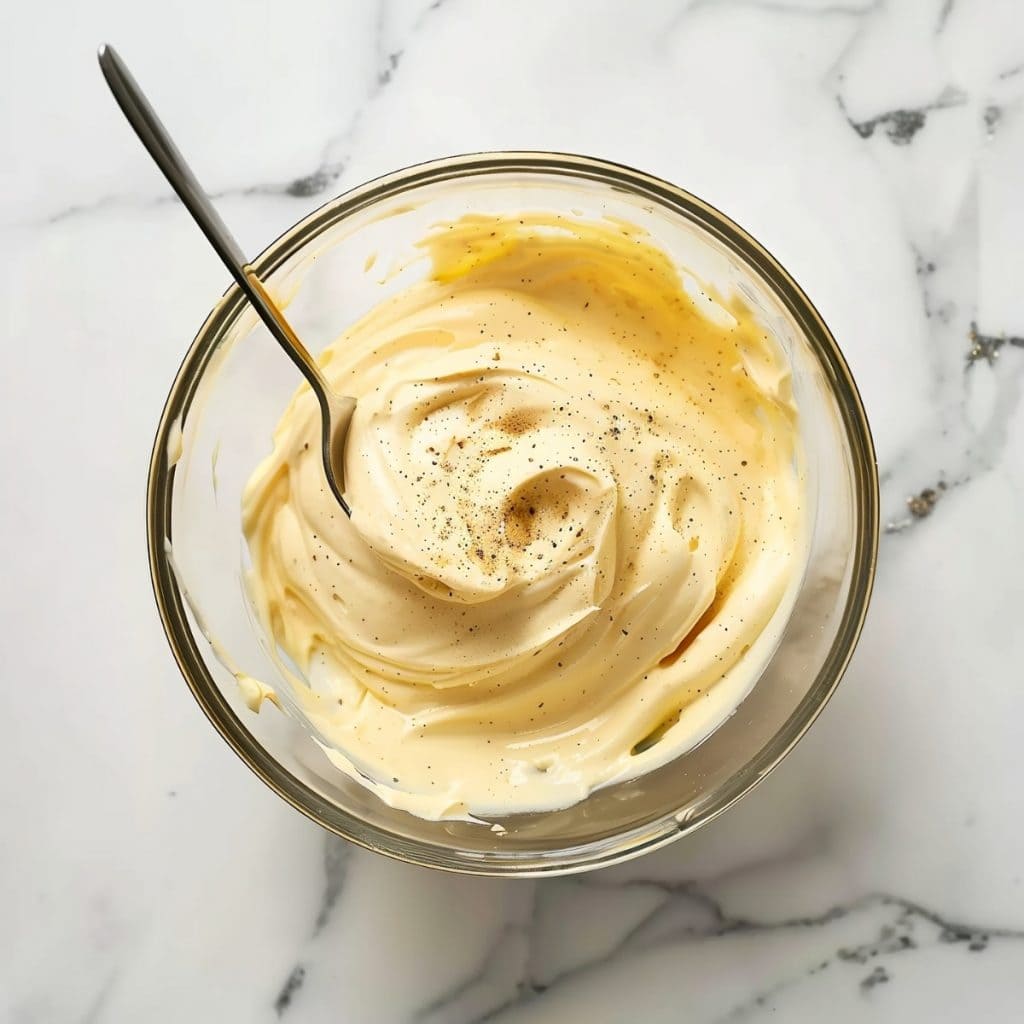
[{"left": 146, "top": 151, "right": 879, "bottom": 878}]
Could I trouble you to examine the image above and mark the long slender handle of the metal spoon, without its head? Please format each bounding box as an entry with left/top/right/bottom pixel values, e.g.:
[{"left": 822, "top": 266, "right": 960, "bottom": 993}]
[{"left": 98, "top": 44, "right": 330, "bottom": 395}]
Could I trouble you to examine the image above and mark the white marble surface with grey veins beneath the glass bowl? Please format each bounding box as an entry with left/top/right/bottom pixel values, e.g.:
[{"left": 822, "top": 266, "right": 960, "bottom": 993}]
[{"left": 0, "top": 0, "right": 1024, "bottom": 1024}]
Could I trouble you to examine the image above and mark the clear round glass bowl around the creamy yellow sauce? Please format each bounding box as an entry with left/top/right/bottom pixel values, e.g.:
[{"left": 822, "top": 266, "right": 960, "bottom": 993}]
[{"left": 147, "top": 153, "right": 879, "bottom": 876}]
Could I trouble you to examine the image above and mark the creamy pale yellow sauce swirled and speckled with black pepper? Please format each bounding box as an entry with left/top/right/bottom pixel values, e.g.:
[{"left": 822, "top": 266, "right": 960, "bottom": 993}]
[{"left": 244, "top": 214, "right": 805, "bottom": 818}]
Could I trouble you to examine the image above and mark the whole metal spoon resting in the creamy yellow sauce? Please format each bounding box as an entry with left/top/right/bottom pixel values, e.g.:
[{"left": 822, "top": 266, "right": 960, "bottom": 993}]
[{"left": 98, "top": 45, "right": 355, "bottom": 516}]
